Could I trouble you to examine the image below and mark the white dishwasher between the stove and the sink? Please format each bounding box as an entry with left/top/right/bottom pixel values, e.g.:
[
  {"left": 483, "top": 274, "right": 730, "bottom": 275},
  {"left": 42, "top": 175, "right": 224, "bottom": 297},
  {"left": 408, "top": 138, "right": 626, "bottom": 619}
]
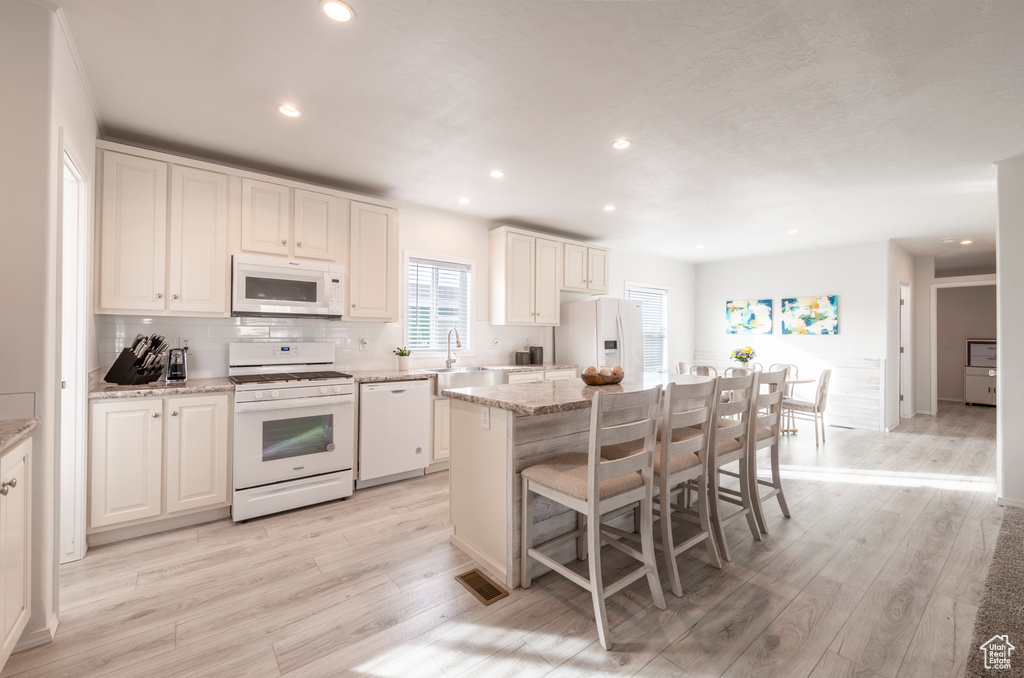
[{"left": 355, "top": 379, "right": 431, "bottom": 488}]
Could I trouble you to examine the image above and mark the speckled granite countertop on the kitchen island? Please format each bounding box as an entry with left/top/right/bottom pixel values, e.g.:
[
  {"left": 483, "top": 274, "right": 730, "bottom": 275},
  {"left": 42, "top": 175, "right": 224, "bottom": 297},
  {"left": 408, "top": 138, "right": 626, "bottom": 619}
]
[{"left": 441, "top": 374, "right": 710, "bottom": 415}]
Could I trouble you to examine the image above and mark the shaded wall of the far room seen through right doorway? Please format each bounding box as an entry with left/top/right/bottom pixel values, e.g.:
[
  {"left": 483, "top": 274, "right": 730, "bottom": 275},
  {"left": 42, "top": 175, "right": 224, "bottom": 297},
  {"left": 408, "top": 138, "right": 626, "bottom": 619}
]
[{"left": 935, "top": 285, "right": 996, "bottom": 401}]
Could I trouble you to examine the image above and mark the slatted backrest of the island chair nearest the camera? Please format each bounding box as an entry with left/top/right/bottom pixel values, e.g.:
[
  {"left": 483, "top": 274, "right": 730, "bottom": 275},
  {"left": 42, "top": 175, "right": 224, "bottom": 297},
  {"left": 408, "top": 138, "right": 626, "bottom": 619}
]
[{"left": 587, "top": 386, "right": 662, "bottom": 498}]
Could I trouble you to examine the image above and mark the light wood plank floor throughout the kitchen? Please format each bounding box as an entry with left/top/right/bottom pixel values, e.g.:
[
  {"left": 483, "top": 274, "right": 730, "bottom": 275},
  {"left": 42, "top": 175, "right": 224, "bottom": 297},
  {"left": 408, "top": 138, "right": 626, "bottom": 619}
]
[{"left": 2, "top": 402, "right": 1001, "bottom": 678}]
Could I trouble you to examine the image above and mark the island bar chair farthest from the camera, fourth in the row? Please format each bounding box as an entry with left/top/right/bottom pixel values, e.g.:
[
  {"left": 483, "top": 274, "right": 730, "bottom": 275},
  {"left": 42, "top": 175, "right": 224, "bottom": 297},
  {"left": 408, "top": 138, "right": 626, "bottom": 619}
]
[{"left": 748, "top": 370, "right": 790, "bottom": 534}]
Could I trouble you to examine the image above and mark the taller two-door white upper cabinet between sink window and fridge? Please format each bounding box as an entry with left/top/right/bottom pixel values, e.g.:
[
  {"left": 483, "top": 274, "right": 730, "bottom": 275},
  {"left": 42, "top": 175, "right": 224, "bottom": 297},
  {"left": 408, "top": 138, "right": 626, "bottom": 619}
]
[{"left": 490, "top": 227, "right": 562, "bottom": 325}]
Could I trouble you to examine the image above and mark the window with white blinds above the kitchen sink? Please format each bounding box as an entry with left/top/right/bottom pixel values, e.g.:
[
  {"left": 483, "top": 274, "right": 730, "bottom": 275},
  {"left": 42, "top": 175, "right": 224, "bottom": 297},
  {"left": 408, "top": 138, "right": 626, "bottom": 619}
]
[{"left": 407, "top": 257, "right": 472, "bottom": 351}]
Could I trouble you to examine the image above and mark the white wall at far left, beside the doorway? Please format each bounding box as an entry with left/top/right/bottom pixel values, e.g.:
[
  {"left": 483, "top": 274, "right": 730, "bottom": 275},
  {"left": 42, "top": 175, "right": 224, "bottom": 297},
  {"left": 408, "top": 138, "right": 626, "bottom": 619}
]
[{"left": 0, "top": 0, "right": 96, "bottom": 646}]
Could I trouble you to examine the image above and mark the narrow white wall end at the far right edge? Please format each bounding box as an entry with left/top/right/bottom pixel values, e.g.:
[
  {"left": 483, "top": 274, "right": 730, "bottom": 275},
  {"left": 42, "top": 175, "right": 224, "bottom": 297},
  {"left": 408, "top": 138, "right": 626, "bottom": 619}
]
[{"left": 995, "top": 158, "right": 1024, "bottom": 506}]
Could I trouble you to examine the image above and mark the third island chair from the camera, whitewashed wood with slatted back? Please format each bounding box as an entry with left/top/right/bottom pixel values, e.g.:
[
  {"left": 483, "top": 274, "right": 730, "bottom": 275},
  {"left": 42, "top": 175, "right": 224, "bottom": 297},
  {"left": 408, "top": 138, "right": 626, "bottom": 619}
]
[{"left": 708, "top": 372, "right": 761, "bottom": 560}]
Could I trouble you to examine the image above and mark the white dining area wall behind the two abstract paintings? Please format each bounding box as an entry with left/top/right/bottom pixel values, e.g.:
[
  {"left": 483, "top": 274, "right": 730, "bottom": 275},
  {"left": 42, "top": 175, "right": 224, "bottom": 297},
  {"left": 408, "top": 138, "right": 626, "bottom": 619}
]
[{"left": 694, "top": 243, "right": 891, "bottom": 429}]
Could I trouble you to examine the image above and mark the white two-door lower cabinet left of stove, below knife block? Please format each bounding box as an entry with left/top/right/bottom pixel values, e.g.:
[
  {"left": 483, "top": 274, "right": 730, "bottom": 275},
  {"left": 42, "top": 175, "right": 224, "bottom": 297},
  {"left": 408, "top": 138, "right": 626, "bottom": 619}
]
[{"left": 89, "top": 394, "right": 230, "bottom": 531}]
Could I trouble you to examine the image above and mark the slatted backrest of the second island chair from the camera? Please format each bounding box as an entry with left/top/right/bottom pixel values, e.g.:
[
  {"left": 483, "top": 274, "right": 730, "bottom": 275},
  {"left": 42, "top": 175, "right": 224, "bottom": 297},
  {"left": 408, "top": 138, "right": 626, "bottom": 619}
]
[{"left": 658, "top": 379, "right": 718, "bottom": 473}]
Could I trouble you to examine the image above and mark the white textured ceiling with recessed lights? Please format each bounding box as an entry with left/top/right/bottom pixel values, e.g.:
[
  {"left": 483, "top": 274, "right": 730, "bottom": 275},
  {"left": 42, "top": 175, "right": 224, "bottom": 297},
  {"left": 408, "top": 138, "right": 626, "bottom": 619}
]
[{"left": 62, "top": 0, "right": 1024, "bottom": 261}]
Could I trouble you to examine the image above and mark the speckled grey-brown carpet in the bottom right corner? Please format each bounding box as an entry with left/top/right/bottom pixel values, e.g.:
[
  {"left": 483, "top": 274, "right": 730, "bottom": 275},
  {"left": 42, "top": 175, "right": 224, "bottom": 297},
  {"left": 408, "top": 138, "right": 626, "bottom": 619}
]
[{"left": 965, "top": 507, "right": 1024, "bottom": 678}]
